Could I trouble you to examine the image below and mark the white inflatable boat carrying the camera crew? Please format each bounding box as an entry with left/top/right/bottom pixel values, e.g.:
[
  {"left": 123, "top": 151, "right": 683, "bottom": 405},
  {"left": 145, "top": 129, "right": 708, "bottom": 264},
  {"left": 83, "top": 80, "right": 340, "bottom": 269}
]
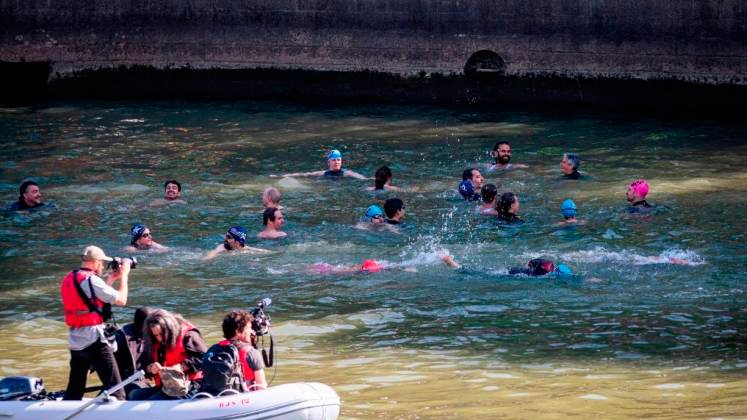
[{"left": 0, "top": 382, "right": 340, "bottom": 420}]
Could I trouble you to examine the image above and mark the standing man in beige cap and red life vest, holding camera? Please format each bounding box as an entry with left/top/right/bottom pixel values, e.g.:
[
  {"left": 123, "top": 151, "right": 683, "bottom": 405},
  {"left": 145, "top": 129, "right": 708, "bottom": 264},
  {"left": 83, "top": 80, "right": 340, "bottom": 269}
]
[{"left": 60, "top": 245, "right": 132, "bottom": 400}]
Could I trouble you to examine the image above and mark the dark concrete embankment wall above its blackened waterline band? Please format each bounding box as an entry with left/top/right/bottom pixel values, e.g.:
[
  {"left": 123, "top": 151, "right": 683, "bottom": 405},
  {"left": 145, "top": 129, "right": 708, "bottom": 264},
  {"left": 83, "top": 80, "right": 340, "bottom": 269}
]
[{"left": 0, "top": 0, "right": 747, "bottom": 111}]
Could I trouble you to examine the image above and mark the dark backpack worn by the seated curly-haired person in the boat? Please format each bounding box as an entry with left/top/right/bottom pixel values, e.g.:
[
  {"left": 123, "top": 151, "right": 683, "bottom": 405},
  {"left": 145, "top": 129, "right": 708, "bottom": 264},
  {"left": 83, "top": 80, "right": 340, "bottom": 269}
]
[{"left": 200, "top": 343, "right": 247, "bottom": 395}]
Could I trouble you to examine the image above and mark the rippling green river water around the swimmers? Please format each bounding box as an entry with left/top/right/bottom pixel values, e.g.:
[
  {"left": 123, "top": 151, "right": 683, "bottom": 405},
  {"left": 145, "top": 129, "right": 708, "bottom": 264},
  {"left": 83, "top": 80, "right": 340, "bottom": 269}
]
[{"left": 0, "top": 102, "right": 747, "bottom": 419}]
